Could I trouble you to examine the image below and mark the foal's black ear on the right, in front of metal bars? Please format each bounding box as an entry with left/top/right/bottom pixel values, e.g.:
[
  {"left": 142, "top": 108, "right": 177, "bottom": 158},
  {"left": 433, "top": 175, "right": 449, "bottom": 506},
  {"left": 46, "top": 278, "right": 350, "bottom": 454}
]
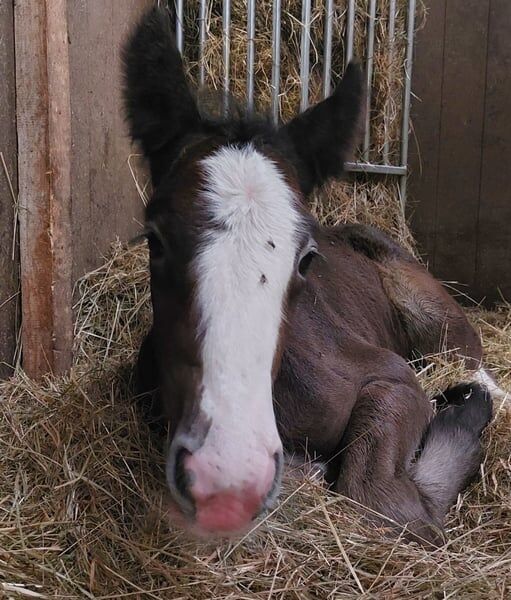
[{"left": 279, "top": 63, "right": 364, "bottom": 195}]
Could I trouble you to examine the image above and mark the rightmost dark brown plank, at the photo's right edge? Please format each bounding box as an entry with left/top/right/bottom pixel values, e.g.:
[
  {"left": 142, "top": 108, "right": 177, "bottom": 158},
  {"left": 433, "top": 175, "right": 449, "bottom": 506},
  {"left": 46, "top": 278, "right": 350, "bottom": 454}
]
[{"left": 474, "top": 0, "right": 511, "bottom": 301}]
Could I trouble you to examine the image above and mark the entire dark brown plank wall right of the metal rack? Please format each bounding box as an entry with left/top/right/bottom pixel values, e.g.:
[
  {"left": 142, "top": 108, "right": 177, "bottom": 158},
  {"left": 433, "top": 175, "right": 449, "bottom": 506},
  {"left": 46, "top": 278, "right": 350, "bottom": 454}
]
[{"left": 408, "top": 0, "right": 511, "bottom": 304}]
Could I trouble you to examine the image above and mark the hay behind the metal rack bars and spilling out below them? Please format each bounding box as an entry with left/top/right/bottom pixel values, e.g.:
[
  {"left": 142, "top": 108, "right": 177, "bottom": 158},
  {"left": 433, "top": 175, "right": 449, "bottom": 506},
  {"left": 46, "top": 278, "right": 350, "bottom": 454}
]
[{"left": 176, "top": 0, "right": 425, "bottom": 250}]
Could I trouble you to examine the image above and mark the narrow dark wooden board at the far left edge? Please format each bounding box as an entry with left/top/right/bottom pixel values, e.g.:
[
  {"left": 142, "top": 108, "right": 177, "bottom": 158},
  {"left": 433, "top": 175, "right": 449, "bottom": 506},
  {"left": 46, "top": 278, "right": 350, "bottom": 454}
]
[{"left": 0, "top": 0, "right": 19, "bottom": 378}]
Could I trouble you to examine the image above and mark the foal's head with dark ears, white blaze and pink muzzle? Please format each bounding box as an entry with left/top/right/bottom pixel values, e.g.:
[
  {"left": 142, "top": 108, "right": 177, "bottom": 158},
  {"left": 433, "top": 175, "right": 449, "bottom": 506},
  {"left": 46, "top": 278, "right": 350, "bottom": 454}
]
[{"left": 125, "top": 10, "right": 362, "bottom": 533}]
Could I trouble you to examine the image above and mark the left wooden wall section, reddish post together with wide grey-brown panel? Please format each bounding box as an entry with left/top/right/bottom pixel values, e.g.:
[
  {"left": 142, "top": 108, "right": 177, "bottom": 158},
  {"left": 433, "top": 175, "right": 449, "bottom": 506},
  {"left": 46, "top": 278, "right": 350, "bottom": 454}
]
[{"left": 10, "top": 0, "right": 153, "bottom": 376}]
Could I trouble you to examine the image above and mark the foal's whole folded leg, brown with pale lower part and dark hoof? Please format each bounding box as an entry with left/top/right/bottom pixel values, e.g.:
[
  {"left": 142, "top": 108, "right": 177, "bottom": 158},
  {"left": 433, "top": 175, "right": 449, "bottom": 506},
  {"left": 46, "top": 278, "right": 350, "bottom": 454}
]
[{"left": 335, "top": 368, "right": 492, "bottom": 545}]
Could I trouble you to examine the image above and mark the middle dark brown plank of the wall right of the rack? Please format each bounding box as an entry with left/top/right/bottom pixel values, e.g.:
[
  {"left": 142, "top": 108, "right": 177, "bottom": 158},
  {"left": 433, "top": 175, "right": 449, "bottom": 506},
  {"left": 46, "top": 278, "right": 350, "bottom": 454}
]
[{"left": 434, "top": 0, "right": 490, "bottom": 289}]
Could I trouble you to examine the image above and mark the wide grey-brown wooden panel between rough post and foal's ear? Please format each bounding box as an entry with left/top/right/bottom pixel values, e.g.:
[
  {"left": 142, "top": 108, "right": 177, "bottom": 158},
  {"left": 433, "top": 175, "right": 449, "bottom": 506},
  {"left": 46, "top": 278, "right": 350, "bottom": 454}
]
[{"left": 68, "top": 0, "right": 152, "bottom": 279}]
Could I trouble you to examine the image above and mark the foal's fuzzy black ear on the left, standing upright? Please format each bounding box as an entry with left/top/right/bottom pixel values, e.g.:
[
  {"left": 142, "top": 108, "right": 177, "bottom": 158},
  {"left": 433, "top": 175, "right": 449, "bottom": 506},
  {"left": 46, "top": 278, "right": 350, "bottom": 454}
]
[{"left": 123, "top": 7, "right": 201, "bottom": 184}]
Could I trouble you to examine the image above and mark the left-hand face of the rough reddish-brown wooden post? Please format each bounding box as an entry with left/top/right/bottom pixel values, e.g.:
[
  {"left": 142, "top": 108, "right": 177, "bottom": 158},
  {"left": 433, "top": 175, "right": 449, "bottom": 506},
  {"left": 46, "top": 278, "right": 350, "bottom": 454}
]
[{"left": 15, "top": 2, "right": 53, "bottom": 376}]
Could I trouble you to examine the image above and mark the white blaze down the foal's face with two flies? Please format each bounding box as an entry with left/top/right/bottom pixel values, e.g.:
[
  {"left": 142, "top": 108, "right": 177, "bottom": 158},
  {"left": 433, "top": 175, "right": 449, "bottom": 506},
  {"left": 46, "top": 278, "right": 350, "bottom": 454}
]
[{"left": 195, "top": 146, "right": 300, "bottom": 485}]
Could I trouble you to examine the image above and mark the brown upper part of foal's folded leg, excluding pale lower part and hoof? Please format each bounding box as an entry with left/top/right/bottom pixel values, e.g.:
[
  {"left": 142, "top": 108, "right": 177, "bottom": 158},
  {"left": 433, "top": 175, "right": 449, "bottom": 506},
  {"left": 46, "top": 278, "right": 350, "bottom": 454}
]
[{"left": 335, "top": 380, "right": 442, "bottom": 545}]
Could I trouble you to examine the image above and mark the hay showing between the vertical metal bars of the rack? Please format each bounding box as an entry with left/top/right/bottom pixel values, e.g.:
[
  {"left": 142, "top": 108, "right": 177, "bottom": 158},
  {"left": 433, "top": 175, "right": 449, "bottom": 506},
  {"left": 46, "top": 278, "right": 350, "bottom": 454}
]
[{"left": 184, "top": 0, "right": 416, "bottom": 161}]
